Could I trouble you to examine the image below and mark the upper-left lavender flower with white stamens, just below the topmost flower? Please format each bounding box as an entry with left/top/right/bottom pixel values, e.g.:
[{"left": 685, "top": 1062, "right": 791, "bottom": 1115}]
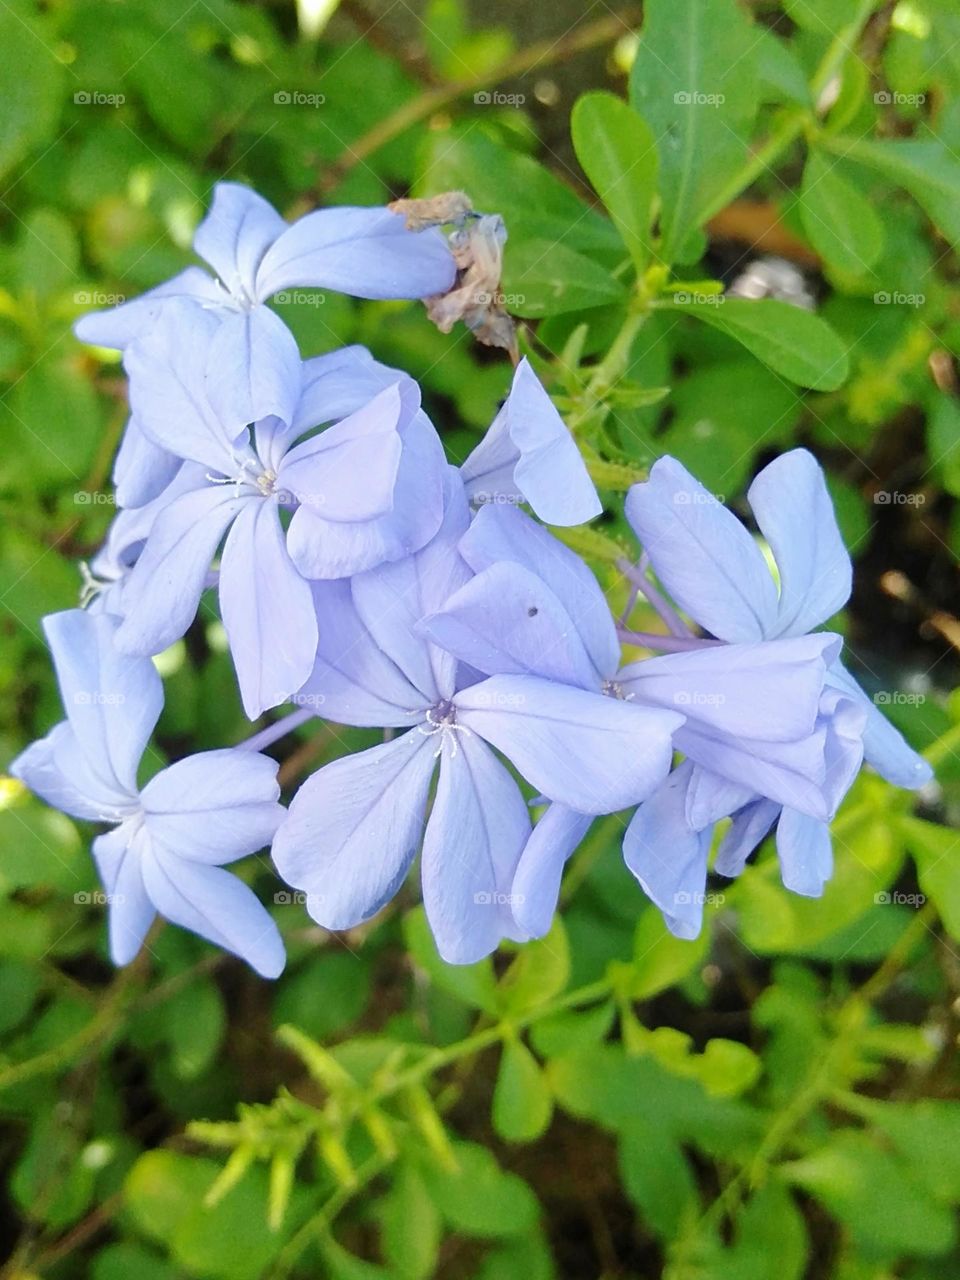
[{"left": 108, "top": 316, "right": 443, "bottom": 719}]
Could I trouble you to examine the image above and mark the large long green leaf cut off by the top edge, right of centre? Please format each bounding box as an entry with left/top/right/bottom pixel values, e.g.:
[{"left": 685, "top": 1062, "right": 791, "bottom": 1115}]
[{"left": 630, "top": 0, "right": 759, "bottom": 262}]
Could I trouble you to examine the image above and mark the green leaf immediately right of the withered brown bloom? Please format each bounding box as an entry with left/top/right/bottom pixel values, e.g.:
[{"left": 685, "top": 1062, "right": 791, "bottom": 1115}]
[{"left": 503, "top": 239, "right": 626, "bottom": 320}]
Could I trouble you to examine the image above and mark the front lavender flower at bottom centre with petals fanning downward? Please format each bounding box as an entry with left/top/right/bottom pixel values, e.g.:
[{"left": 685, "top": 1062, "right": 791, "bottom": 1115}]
[{"left": 274, "top": 471, "right": 682, "bottom": 964}]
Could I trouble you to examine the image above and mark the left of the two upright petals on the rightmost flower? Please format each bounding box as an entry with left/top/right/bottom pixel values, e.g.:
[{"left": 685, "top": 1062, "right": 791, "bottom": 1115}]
[{"left": 625, "top": 457, "right": 777, "bottom": 643}]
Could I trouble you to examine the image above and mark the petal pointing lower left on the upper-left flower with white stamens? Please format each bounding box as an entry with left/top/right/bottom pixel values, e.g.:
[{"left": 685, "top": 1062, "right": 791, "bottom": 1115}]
[{"left": 116, "top": 484, "right": 248, "bottom": 654}]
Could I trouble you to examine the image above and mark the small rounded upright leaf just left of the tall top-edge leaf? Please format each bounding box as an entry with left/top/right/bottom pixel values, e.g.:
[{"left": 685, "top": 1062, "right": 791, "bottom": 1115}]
[{"left": 570, "top": 92, "right": 657, "bottom": 274}]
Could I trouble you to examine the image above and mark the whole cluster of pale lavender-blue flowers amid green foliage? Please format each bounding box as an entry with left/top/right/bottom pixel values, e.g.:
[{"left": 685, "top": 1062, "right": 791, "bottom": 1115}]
[{"left": 12, "top": 184, "right": 929, "bottom": 975}]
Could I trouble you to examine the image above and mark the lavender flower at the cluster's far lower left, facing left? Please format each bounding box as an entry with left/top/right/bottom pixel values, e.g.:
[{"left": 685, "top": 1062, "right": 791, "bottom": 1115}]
[{"left": 10, "top": 609, "right": 284, "bottom": 978}]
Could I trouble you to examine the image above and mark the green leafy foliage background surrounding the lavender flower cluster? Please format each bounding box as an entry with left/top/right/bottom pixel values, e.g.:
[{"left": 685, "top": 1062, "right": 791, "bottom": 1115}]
[{"left": 0, "top": 0, "right": 960, "bottom": 1280}]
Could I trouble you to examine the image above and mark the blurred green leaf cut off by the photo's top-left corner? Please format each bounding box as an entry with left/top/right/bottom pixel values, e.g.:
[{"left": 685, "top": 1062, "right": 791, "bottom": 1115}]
[{"left": 0, "top": 0, "right": 65, "bottom": 183}]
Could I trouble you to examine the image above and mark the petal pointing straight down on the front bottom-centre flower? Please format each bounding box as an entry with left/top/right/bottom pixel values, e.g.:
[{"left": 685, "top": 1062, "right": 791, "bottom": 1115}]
[{"left": 421, "top": 733, "right": 530, "bottom": 964}]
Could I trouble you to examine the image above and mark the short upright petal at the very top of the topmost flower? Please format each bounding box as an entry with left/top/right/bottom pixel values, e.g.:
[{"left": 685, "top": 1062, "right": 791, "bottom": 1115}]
[{"left": 193, "top": 182, "right": 287, "bottom": 301}]
